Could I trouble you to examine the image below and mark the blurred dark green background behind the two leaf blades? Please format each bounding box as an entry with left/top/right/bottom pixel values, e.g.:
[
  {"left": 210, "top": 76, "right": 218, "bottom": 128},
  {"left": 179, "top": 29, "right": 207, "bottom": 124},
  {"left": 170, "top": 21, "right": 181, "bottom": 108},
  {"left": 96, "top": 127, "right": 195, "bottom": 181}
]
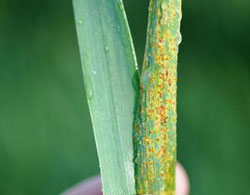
[{"left": 0, "top": 0, "right": 250, "bottom": 195}]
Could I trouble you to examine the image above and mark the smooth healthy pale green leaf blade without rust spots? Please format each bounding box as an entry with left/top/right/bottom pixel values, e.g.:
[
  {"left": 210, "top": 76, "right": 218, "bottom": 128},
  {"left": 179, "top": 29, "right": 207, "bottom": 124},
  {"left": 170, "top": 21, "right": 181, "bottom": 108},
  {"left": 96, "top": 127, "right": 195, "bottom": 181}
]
[{"left": 73, "top": 0, "right": 139, "bottom": 195}]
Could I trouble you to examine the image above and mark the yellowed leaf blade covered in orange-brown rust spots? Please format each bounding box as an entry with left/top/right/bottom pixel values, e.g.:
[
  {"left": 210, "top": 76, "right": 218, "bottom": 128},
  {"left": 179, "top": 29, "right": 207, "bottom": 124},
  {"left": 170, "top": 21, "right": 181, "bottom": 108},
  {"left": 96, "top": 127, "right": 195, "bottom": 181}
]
[{"left": 135, "top": 0, "right": 181, "bottom": 195}]
